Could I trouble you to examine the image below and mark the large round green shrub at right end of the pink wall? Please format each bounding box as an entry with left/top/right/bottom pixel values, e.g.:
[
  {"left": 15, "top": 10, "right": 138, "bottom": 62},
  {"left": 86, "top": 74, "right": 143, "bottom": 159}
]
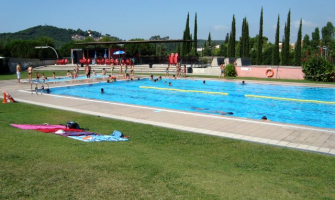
[{"left": 302, "top": 55, "right": 334, "bottom": 82}]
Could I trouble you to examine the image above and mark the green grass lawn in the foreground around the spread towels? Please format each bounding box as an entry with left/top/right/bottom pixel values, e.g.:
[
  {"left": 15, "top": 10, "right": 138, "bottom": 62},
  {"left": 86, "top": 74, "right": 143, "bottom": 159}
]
[{"left": 0, "top": 103, "right": 335, "bottom": 199}]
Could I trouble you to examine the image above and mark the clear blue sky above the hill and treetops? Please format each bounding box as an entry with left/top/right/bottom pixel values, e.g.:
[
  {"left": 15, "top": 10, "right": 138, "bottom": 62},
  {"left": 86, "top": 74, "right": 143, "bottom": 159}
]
[{"left": 0, "top": 0, "right": 335, "bottom": 43}]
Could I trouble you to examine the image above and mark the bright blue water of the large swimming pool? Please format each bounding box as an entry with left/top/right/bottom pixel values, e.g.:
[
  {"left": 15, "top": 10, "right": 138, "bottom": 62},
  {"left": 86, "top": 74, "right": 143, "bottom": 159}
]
[{"left": 51, "top": 79, "right": 335, "bottom": 128}]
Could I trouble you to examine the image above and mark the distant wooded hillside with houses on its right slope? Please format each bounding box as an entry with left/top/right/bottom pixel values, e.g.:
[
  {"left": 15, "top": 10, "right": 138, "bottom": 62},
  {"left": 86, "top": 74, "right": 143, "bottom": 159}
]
[{"left": 0, "top": 25, "right": 100, "bottom": 47}]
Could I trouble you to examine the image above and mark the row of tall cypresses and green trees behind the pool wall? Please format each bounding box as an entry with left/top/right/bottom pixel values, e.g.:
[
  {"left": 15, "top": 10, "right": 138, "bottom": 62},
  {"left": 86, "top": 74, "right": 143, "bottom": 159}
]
[{"left": 184, "top": 8, "right": 335, "bottom": 66}]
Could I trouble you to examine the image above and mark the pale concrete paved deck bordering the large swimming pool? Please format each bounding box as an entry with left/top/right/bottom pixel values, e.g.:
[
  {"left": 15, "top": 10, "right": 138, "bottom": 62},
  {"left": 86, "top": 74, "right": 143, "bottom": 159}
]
[{"left": 0, "top": 79, "right": 335, "bottom": 156}]
